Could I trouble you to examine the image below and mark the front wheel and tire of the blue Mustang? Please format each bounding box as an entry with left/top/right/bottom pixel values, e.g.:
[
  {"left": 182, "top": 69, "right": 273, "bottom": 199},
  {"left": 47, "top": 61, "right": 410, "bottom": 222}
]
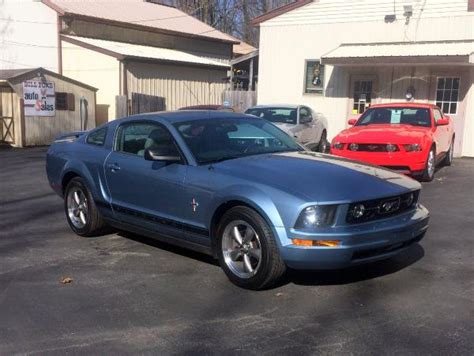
[{"left": 217, "top": 206, "right": 286, "bottom": 290}]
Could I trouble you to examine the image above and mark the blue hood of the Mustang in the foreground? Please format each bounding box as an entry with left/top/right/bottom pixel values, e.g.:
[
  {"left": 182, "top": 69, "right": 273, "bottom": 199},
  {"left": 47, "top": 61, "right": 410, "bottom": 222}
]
[{"left": 214, "top": 151, "right": 421, "bottom": 203}]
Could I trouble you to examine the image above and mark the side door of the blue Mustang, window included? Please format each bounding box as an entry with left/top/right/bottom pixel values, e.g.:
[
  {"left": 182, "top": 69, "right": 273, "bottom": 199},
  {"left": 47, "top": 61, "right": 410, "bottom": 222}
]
[{"left": 104, "top": 121, "right": 187, "bottom": 237}]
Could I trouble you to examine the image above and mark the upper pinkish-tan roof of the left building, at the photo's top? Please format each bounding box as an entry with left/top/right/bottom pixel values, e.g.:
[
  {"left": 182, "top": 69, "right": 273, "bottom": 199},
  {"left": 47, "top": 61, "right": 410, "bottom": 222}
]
[{"left": 42, "top": 0, "right": 239, "bottom": 43}]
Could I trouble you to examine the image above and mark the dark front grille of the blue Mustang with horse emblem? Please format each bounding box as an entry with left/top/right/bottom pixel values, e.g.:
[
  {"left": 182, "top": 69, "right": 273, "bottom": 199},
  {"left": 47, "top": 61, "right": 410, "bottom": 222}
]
[{"left": 346, "top": 190, "right": 420, "bottom": 224}]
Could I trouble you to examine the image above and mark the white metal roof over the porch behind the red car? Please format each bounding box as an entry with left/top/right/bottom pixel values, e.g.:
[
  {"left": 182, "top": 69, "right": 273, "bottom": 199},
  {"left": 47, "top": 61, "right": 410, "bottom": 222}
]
[{"left": 322, "top": 40, "right": 474, "bottom": 64}]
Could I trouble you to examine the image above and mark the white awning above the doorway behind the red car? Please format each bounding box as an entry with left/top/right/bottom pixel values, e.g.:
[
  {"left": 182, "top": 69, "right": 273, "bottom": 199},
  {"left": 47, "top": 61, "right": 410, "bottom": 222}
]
[{"left": 321, "top": 40, "right": 474, "bottom": 65}]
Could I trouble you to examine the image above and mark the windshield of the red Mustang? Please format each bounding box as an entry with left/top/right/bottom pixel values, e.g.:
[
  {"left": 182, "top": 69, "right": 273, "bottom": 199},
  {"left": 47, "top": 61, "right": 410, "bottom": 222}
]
[{"left": 356, "top": 107, "right": 431, "bottom": 127}]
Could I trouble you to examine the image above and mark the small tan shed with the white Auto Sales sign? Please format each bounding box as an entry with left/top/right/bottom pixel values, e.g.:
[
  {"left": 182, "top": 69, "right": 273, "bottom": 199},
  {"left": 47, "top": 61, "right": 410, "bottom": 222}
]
[{"left": 0, "top": 68, "right": 97, "bottom": 147}]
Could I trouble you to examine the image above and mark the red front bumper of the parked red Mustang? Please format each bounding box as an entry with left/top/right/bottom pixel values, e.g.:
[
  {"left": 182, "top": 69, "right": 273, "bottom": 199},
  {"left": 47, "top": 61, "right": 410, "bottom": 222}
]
[{"left": 331, "top": 148, "right": 427, "bottom": 175}]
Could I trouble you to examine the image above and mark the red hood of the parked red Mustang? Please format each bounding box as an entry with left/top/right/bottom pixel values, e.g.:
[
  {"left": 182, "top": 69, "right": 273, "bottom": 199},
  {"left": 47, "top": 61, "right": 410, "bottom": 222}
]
[{"left": 334, "top": 124, "right": 431, "bottom": 143}]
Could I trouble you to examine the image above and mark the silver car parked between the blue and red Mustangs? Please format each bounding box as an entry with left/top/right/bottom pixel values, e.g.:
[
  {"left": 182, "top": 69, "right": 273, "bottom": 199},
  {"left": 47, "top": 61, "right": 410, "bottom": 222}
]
[{"left": 245, "top": 105, "right": 329, "bottom": 152}]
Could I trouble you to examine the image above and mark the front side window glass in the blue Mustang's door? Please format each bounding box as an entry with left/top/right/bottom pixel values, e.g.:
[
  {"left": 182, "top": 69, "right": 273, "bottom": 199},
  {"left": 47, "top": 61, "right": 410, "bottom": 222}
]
[{"left": 115, "top": 122, "right": 179, "bottom": 157}]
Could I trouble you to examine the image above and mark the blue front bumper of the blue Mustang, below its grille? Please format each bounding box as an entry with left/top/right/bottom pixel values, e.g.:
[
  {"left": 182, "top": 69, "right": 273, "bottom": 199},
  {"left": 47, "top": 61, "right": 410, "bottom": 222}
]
[{"left": 278, "top": 204, "right": 429, "bottom": 270}]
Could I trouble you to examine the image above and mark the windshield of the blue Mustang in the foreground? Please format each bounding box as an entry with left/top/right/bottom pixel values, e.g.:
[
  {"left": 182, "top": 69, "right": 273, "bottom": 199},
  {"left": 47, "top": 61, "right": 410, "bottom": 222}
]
[{"left": 174, "top": 117, "right": 304, "bottom": 164}]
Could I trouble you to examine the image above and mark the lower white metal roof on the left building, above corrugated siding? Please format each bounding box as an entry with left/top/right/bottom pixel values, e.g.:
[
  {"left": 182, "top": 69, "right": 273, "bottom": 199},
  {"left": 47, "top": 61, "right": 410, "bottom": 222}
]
[{"left": 61, "top": 35, "right": 230, "bottom": 68}]
